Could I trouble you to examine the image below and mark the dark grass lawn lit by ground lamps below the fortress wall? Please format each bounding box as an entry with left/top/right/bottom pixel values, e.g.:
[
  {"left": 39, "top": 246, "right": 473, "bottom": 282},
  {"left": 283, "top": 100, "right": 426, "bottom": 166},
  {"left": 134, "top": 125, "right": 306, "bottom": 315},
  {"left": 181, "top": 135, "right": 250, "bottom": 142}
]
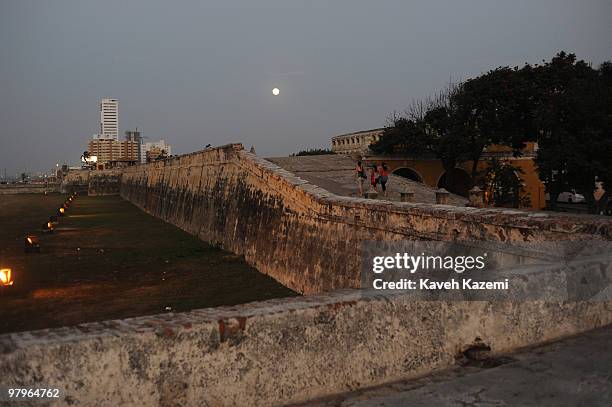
[{"left": 0, "top": 194, "right": 297, "bottom": 333}]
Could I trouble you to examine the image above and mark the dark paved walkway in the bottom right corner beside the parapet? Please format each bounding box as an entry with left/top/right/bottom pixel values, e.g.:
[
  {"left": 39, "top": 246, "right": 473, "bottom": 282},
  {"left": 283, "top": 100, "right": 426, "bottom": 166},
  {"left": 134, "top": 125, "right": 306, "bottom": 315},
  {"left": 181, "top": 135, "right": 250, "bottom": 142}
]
[{"left": 301, "top": 326, "right": 612, "bottom": 407}]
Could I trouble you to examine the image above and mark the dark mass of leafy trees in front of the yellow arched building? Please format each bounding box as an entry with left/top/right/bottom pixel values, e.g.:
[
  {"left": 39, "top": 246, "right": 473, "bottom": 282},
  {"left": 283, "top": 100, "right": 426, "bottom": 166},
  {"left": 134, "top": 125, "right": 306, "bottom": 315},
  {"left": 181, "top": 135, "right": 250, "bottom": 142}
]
[{"left": 371, "top": 52, "right": 612, "bottom": 212}]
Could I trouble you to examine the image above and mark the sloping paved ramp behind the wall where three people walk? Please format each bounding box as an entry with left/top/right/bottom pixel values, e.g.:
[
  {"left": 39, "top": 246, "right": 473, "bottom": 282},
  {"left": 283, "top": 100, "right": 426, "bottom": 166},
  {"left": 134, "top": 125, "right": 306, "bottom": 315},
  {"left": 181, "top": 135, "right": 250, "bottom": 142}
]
[{"left": 266, "top": 154, "right": 467, "bottom": 206}]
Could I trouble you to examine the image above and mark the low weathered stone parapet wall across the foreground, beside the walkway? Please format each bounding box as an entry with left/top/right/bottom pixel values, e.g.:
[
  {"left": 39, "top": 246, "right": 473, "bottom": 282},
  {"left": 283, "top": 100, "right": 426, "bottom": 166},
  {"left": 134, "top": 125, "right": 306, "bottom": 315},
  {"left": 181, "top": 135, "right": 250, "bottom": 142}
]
[{"left": 0, "top": 291, "right": 612, "bottom": 406}]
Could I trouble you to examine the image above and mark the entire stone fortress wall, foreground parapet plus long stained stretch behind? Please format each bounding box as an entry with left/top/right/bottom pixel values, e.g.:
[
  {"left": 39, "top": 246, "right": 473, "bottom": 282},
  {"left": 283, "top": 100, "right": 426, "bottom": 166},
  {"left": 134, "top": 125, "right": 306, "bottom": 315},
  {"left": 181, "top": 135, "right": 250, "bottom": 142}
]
[{"left": 0, "top": 144, "right": 612, "bottom": 406}]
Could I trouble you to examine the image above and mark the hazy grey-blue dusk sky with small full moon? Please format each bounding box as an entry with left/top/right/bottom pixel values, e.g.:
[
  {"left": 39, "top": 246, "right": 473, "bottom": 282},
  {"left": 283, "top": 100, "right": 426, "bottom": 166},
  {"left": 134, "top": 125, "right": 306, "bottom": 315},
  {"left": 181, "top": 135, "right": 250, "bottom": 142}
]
[{"left": 0, "top": 0, "right": 612, "bottom": 176}]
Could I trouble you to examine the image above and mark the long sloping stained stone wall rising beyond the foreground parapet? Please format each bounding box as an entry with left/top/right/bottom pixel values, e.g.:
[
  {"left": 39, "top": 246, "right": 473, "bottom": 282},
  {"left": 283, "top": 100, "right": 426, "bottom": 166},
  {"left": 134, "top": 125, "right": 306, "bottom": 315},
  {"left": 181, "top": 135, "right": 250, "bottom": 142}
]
[{"left": 121, "top": 144, "right": 612, "bottom": 293}]
